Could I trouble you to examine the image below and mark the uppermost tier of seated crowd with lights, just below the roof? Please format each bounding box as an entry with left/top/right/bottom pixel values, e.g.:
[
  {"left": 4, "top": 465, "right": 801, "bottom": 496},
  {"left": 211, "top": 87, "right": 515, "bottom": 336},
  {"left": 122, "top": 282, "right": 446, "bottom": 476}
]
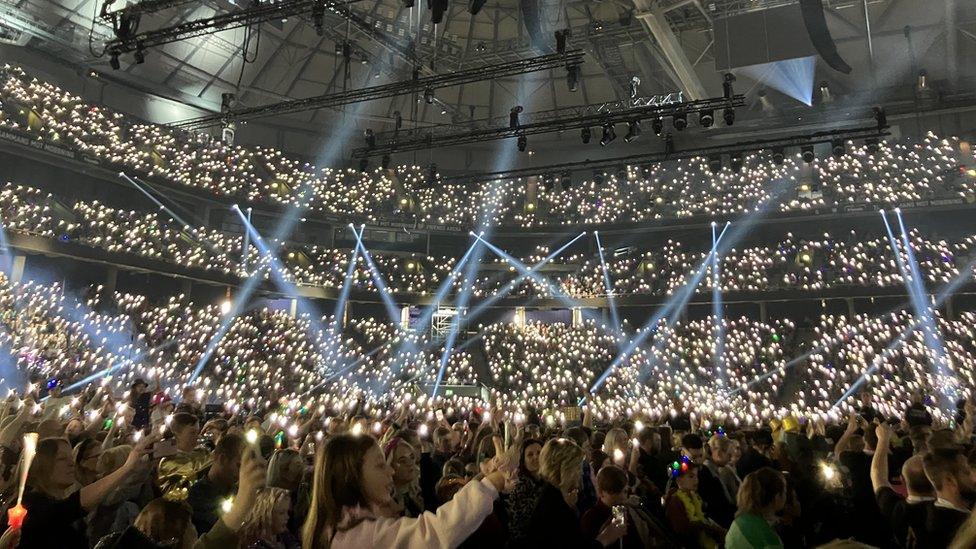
[{"left": 0, "top": 65, "right": 976, "bottom": 227}]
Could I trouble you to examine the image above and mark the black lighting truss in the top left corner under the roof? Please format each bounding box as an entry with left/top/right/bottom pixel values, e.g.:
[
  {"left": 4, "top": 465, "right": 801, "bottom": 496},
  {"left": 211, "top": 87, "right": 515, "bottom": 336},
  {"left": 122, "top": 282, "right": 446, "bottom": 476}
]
[{"left": 105, "top": 0, "right": 359, "bottom": 57}]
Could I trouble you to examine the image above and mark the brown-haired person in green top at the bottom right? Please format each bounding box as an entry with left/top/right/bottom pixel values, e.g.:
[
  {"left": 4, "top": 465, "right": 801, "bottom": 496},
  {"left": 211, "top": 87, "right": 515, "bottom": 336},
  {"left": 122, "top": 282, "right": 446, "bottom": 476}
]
[{"left": 725, "top": 467, "right": 786, "bottom": 549}]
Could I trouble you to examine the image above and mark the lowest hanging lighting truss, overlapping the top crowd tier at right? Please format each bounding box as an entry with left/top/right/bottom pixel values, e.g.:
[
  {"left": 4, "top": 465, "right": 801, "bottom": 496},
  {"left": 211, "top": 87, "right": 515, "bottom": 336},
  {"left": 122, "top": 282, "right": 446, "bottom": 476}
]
[{"left": 441, "top": 125, "right": 890, "bottom": 183}]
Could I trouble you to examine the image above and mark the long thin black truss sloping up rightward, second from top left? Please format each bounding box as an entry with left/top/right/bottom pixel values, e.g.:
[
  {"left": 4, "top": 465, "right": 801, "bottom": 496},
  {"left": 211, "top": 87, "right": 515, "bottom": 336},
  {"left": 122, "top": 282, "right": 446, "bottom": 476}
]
[{"left": 173, "top": 50, "right": 583, "bottom": 129}]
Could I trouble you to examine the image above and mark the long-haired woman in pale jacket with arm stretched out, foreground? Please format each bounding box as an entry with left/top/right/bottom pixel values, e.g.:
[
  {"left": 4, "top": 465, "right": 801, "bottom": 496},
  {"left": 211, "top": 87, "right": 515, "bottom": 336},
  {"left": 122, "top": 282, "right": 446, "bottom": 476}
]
[{"left": 302, "top": 434, "right": 505, "bottom": 549}]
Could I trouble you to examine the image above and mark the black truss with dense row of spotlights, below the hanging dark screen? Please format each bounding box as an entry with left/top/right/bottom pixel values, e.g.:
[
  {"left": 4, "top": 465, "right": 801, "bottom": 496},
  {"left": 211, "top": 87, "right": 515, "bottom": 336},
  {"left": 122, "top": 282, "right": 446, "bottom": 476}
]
[{"left": 352, "top": 95, "right": 745, "bottom": 158}]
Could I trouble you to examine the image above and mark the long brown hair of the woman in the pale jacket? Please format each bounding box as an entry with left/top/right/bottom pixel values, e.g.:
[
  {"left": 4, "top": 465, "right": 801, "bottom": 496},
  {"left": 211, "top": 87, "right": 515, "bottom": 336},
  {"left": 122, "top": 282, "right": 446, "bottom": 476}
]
[{"left": 302, "top": 433, "right": 376, "bottom": 549}]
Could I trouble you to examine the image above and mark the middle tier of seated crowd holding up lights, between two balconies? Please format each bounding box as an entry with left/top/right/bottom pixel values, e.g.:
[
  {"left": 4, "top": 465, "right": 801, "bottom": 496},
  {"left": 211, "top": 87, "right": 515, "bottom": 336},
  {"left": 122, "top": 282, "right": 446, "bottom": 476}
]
[{"left": 0, "top": 184, "right": 976, "bottom": 298}]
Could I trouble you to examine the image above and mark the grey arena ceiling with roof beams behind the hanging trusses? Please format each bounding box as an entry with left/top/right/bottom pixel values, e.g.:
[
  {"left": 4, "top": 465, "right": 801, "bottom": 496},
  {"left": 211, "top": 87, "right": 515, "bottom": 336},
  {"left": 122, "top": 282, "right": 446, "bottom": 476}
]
[{"left": 0, "top": 0, "right": 976, "bottom": 143}]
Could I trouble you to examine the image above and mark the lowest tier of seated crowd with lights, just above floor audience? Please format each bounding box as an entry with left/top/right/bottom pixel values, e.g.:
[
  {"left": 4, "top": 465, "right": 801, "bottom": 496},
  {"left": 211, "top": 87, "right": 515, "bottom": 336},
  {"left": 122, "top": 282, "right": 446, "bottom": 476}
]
[{"left": 0, "top": 278, "right": 976, "bottom": 425}]
